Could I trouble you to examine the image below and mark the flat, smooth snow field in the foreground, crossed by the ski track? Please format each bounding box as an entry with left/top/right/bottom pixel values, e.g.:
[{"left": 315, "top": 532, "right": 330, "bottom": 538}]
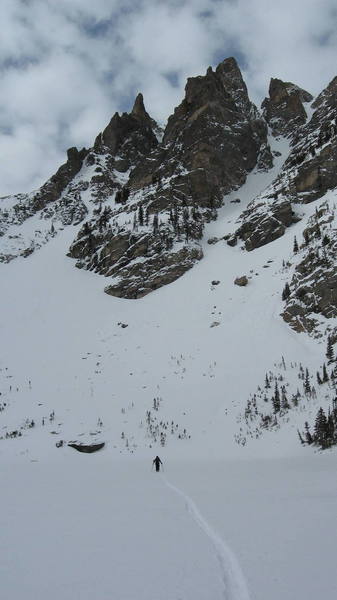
[{"left": 0, "top": 448, "right": 337, "bottom": 600}]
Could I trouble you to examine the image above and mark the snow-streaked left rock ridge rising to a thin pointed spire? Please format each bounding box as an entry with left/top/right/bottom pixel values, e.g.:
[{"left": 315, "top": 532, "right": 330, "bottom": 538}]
[{"left": 0, "top": 94, "right": 158, "bottom": 262}]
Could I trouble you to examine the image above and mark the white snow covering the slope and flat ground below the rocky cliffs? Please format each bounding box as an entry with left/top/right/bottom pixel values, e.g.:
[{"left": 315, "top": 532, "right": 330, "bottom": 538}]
[{"left": 0, "top": 134, "right": 337, "bottom": 600}]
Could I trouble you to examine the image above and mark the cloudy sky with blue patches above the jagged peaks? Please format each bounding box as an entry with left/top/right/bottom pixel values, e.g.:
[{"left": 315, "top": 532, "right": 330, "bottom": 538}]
[{"left": 0, "top": 0, "right": 337, "bottom": 195}]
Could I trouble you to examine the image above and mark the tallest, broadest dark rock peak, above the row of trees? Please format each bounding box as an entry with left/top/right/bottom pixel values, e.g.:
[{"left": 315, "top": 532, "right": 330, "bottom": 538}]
[{"left": 130, "top": 58, "right": 272, "bottom": 204}]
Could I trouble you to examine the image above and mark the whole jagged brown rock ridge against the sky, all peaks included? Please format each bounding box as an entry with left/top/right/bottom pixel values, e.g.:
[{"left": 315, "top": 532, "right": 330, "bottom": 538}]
[{"left": 0, "top": 58, "right": 337, "bottom": 299}]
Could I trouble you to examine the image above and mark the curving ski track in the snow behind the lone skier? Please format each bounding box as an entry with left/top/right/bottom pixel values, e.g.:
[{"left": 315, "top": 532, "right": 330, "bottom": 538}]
[{"left": 161, "top": 475, "right": 250, "bottom": 600}]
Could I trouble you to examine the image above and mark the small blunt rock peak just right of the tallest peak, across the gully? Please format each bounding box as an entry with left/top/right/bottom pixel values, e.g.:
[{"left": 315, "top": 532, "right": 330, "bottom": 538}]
[{"left": 261, "top": 79, "right": 313, "bottom": 137}]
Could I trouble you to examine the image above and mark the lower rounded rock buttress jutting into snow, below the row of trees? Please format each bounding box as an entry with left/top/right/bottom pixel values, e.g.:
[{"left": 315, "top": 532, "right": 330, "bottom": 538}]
[{"left": 69, "top": 205, "right": 203, "bottom": 298}]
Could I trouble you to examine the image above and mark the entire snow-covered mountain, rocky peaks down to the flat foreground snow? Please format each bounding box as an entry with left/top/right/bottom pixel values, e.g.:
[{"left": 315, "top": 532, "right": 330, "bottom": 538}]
[{"left": 0, "top": 58, "right": 337, "bottom": 600}]
